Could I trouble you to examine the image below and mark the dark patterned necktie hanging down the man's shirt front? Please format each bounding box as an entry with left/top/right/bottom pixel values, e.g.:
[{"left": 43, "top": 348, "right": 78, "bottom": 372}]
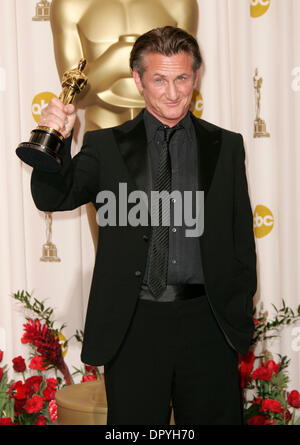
[{"left": 147, "top": 125, "right": 179, "bottom": 298}]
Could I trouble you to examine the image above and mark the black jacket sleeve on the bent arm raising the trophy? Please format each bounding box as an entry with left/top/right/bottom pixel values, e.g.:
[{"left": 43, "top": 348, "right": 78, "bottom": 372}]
[{"left": 31, "top": 133, "right": 99, "bottom": 212}]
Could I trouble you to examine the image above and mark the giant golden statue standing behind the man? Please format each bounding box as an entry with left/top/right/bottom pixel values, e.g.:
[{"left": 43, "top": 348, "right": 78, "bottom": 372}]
[{"left": 50, "top": 0, "right": 198, "bottom": 248}]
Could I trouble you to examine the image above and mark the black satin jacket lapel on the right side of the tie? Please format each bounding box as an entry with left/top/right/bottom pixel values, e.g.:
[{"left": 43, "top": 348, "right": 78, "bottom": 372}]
[{"left": 192, "top": 115, "right": 221, "bottom": 201}]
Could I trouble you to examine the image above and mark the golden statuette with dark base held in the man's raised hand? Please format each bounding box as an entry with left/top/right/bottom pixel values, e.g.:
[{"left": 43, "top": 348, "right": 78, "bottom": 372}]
[{"left": 16, "top": 59, "right": 87, "bottom": 173}]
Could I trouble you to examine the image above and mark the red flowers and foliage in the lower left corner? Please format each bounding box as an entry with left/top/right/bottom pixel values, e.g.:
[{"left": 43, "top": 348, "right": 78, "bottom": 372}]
[{"left": 0, "top": 291, "right": 102, "bottom": 425}]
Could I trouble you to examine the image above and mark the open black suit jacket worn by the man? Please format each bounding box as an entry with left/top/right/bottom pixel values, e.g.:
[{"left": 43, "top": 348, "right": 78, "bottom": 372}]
[{"left": 31, "top": 112, "right": 256, "bottom": 365}]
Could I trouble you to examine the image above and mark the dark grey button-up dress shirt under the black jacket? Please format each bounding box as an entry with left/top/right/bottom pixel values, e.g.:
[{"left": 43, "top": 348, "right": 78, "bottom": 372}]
[{"left": 140, "top": 110, "right": 204, "bottom": 301}]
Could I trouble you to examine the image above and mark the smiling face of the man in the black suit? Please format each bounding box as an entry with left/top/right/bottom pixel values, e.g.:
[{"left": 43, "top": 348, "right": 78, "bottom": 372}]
[{"left": 133, "top": 52, "right": 199, "bottom": 127}]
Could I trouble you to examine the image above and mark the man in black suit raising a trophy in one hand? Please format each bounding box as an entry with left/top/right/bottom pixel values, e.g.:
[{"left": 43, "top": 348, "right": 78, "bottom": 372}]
[{"left": 32, "top": 27, "right": 256, "bottom": 425}]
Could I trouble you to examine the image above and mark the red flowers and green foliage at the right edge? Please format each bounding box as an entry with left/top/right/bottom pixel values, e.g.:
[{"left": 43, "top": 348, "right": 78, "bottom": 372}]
[{"left": 239, "top": 302, "right": 300, "bottom": 425}]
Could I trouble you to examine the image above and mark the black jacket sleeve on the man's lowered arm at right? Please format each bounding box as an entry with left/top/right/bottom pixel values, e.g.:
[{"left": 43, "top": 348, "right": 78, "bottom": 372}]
[{"left": 234, "top": 135, "right": 257, "bottom": 306}]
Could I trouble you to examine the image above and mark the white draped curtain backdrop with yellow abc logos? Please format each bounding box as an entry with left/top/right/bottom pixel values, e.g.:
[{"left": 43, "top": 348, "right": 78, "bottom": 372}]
[{"left": 0, "top": 0, "right": 300, "bottom": 390}]
